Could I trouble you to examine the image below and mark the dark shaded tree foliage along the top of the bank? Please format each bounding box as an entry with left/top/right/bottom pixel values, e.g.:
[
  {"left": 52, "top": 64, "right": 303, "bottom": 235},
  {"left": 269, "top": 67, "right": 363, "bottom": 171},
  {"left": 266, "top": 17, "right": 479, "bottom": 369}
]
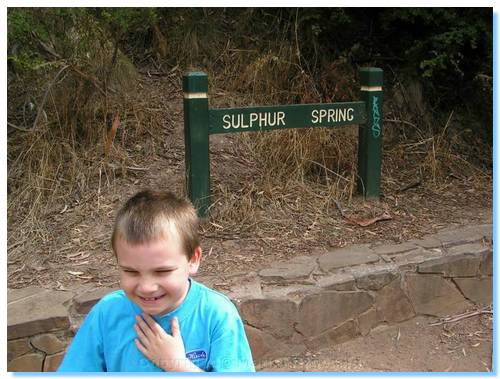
[{"left": 8, "top": 8, "right": 492, "bottom": 101}]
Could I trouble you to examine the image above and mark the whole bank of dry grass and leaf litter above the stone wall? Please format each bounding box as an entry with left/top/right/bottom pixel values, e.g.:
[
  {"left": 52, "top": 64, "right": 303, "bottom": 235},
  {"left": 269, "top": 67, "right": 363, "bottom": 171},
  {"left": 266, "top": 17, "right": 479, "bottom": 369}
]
[{"left": 7, "top": 11, "right": 492, "bottom": 287}]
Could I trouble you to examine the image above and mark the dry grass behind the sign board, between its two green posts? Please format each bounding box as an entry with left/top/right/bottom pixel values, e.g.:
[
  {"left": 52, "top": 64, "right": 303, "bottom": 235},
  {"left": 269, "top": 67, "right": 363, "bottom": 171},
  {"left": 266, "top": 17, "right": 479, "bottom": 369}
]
[{"left": 199, "top": 40, "right": 372, "bottom": 235}]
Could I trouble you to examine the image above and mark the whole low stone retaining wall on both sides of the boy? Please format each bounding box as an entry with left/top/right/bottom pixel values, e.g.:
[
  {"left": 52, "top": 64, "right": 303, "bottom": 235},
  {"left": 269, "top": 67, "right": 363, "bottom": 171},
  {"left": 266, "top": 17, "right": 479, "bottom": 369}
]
[{"left": 7, "top": 224, "right": 492, "bottom": 371}]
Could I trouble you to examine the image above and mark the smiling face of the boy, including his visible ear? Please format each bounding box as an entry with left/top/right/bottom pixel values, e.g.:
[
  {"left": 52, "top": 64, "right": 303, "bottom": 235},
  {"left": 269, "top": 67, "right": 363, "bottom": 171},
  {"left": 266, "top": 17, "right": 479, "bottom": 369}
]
[{"left": 115, "top": 235, "right": 201, "bottom": 316}]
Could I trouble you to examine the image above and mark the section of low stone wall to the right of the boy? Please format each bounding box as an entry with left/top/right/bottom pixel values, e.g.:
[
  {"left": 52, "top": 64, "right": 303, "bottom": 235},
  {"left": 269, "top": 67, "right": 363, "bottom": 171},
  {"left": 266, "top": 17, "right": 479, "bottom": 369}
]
[{"left": 228, "top": 224, "right": 492, "bottom": 362}]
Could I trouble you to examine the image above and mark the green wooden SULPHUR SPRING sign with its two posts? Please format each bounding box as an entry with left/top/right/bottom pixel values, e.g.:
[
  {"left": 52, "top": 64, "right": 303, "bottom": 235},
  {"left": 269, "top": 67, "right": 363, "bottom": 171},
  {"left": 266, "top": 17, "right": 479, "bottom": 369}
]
[{"left": 183, "top": 68, "right": 383, "bottom": 217}]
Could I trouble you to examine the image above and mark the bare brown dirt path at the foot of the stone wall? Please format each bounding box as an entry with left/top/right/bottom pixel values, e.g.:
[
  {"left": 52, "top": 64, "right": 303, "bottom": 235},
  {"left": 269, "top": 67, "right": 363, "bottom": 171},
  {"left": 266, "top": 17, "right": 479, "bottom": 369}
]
[{"left": 257, "top": 314, "right": 493, "bottom": 372}]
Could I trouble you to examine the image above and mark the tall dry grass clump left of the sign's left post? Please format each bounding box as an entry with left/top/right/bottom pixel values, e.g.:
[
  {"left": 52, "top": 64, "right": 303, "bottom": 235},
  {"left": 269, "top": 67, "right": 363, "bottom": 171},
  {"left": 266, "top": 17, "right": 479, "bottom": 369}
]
[{"left": 8, "top": 49, "right": 171, "bottom": 242}]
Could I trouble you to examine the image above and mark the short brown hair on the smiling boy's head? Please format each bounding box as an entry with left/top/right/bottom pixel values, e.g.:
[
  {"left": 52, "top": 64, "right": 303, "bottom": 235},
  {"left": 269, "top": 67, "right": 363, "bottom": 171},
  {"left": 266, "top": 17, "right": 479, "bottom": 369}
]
[{"left": 111, "top": 190, "right": 200, "bottom": 259}]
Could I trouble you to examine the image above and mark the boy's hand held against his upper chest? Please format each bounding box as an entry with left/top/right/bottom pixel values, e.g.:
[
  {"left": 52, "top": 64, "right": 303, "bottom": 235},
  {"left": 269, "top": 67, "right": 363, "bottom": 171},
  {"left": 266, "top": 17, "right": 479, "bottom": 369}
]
[{"left": 134, "top": 313, "right": 201, "bottom": 372}]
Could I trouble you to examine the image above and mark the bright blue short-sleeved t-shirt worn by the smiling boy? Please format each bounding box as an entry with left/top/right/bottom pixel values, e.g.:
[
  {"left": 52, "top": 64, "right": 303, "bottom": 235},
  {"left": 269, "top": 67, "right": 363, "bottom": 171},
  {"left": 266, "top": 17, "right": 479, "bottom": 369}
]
[{"left": 58, "top": 279, "right": 255, "bottom": 372}]
